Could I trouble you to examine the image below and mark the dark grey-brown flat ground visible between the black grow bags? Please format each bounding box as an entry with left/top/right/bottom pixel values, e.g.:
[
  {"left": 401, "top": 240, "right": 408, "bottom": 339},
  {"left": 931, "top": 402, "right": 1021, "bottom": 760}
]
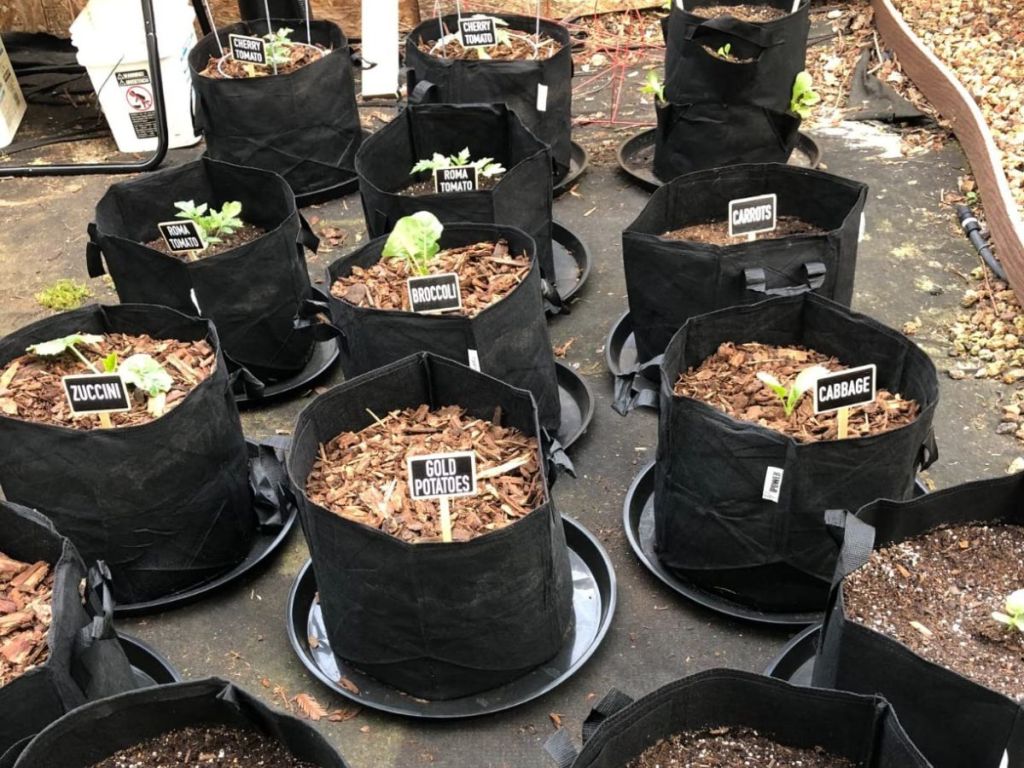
[{"left": 0, "top": 57, "right": 1018, "bottom": 768}]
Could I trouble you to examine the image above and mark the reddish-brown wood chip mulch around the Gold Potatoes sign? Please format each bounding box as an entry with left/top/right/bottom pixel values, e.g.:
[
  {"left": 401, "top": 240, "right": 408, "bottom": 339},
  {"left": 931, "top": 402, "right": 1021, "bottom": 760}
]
[{"left": 306, "top": 406, "right": 545, "bottom": 544}]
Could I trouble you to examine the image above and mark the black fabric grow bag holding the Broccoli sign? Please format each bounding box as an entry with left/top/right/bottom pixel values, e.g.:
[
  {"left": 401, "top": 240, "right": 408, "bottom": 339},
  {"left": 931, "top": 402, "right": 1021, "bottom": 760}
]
[{"left": 327, "top": 224, "right": 561, "bottom": 433}]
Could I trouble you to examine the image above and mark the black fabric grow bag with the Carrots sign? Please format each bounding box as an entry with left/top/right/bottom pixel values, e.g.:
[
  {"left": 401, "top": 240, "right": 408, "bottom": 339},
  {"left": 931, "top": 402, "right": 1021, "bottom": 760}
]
[{"left": 623, "top": 164, "right": 867, "bottom": 374}]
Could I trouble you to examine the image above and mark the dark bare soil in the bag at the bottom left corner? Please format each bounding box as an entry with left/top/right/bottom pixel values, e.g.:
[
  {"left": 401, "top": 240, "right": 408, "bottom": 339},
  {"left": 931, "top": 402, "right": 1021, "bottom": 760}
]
[{"left": 90, "top": 726, "right": 316, "bottom": 768}]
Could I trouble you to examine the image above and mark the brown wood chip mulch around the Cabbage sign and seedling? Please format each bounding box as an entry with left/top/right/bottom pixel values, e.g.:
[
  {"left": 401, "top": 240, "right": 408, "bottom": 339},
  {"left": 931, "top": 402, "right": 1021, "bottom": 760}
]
[{"left": 674, "top": 342, "right": 921, "bottom": 442}]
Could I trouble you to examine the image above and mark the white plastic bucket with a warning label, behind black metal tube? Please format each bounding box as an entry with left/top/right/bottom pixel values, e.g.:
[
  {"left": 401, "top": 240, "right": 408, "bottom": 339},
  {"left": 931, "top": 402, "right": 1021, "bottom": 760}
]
[{"left": 71, "top": 0, "right": 200, "bottom": 153}]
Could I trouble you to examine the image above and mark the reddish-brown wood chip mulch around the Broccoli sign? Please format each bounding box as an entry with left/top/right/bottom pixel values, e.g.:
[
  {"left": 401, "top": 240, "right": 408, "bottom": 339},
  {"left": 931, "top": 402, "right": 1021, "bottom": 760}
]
[{"left": 331, "top": 240, "right": 529, "bottom": 317}]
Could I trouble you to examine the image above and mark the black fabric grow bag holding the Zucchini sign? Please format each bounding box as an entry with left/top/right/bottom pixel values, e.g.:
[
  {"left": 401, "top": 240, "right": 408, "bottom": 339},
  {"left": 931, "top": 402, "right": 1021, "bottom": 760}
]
[{"left": 0, "top": 304, "right": 257, "bottom": 603}]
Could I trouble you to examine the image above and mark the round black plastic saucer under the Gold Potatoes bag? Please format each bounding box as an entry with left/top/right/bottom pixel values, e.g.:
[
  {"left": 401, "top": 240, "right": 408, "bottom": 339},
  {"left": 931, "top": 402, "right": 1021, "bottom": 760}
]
[{"left": 288, "top": 517, "right": 615, "bottom": 719}]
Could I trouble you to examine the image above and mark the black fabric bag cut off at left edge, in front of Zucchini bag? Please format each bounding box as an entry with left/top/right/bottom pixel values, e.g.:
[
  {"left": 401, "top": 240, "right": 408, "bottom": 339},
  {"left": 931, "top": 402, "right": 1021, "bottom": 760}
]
[{"left": 0, "top": 502, "right": 137, "bottom": 755}]
